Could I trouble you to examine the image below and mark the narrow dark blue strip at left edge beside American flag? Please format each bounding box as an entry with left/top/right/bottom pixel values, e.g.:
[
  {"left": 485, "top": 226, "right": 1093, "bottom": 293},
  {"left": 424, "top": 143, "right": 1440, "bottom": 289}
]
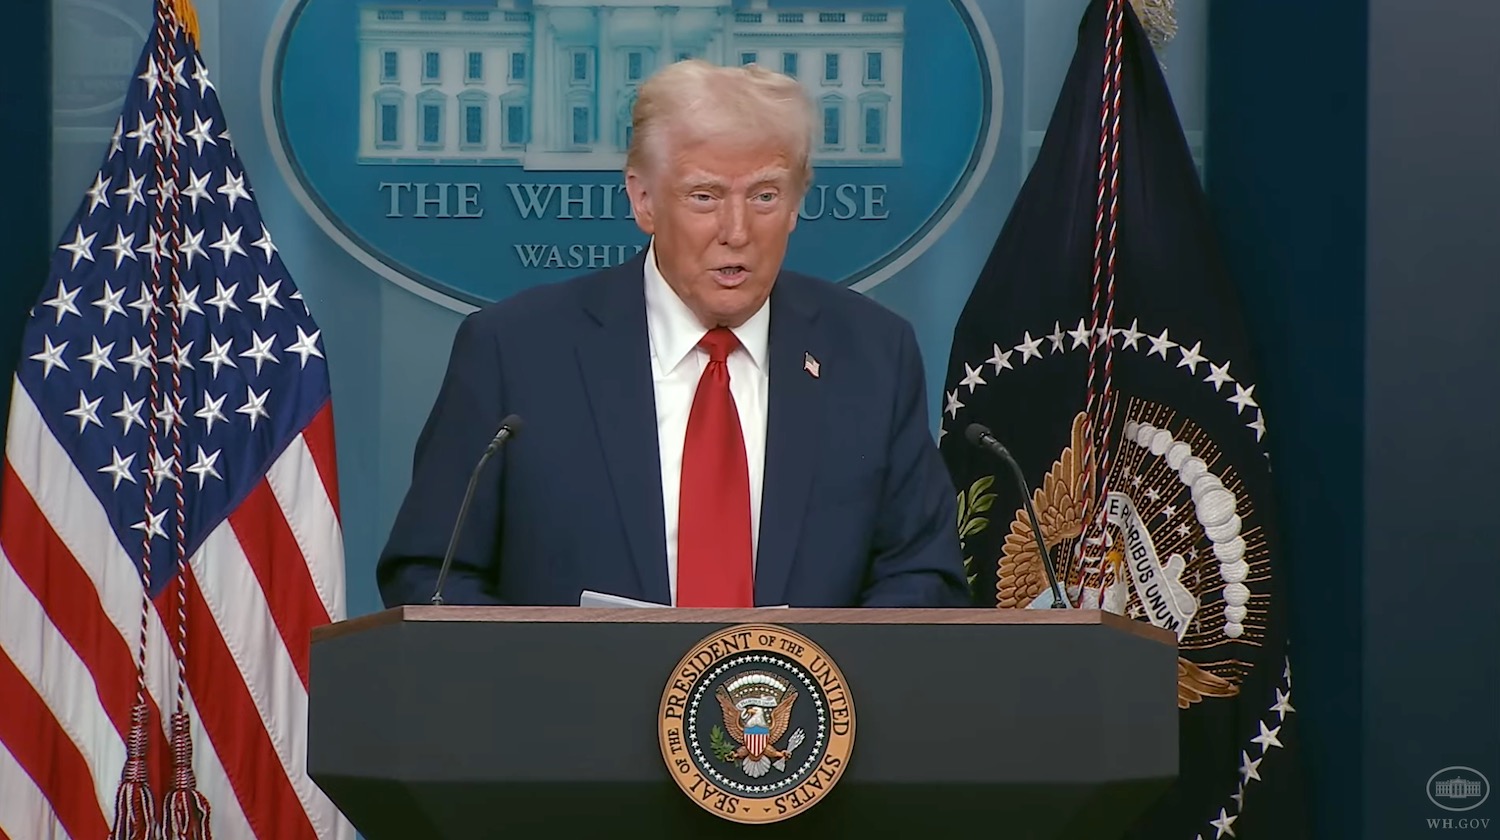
[{"left": 0, "top": 0, "right": 57, "bottom": 444}]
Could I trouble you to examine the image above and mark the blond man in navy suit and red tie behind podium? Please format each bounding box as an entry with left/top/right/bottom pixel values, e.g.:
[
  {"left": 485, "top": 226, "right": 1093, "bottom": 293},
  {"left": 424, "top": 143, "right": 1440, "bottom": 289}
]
[{"left": 377, "top": 62, "right": 969, "bottom": 606}]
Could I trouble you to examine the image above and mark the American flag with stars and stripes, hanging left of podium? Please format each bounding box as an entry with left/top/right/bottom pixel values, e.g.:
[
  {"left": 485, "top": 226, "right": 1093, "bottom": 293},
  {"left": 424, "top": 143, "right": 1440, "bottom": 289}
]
[{"left": 0, "top": 0, "right": 354, "bottom": 840}]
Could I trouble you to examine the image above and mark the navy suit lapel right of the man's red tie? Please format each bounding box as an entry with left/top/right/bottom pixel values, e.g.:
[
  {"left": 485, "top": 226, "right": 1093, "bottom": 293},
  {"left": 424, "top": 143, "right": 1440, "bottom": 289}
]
[{"left": 755, "top": 276, "right": 824, "bottom": 606}]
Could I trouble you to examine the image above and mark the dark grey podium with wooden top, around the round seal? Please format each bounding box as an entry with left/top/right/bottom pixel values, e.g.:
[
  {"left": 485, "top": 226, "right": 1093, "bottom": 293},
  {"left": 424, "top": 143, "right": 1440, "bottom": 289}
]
[{"left": 308, "top": 606, "right": 1178, "bottom": 840}]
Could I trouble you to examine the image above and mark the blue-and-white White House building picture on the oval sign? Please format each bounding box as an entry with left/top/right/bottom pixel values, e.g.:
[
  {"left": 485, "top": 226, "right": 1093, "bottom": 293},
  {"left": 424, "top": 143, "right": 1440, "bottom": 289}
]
[{"left": 359, "top": 0, "right": 905, "bottom": 170}]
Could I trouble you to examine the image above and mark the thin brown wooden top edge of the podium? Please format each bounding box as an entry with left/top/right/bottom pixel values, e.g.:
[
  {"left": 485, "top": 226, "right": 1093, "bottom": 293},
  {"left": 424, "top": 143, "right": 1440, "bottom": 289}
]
[{"left": 312, "top": 605, "right": 1178, "bottom": 645}]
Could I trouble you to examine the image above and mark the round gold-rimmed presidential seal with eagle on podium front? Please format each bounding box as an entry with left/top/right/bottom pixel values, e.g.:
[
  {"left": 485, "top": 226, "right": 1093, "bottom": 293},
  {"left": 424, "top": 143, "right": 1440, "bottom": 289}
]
[{"left": 657, "top": 624, "right": 854, "bottom": 824}]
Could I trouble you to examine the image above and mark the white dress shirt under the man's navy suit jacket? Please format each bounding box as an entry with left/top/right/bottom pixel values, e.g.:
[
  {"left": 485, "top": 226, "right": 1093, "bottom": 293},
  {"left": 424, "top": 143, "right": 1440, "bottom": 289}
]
[{"left": 645, "top": 245, "right": 771, "bottom": 606}]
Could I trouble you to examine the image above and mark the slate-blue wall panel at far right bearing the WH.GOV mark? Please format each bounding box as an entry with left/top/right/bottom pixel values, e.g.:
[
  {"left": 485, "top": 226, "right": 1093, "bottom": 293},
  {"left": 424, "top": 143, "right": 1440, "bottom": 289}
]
[{"left": 1368, "top": 0, "right": 1500, "bottom": 840}]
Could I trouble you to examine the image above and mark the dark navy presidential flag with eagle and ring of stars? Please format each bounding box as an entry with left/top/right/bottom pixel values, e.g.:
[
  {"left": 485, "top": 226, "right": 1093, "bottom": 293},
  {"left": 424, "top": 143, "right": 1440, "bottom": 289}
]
[{"left": 941, "top": 0, "right": 1308, "bottom": 840}]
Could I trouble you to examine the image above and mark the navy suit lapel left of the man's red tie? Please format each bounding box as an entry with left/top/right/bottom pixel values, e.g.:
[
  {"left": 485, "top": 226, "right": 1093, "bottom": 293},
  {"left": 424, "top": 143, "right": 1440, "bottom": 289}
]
[{"left": 578, "top": 257, "right": 671, "bottom": 605}]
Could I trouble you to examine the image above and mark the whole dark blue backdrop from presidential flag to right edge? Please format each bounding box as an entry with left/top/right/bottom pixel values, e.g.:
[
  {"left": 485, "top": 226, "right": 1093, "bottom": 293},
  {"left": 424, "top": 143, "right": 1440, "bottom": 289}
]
[{"left": 1209, "top": 0, "right": 1500, "bottom": 840}]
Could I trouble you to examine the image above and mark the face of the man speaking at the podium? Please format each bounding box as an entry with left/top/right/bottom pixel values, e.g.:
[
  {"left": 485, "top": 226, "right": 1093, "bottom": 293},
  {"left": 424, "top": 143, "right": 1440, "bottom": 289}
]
[{"left": 626, "top": 134, "right": 801, "bottom": 327}]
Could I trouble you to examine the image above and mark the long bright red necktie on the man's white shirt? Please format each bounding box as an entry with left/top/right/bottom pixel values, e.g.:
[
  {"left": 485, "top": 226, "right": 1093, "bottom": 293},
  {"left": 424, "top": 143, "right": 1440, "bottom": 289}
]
[{"left": 677, "top": 327, "right": 755, "bottom": 608}]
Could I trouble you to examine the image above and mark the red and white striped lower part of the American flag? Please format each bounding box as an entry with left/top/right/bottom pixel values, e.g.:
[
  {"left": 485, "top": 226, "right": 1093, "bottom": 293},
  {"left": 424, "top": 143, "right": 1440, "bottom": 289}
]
[{"left": 0, "top": 386, "right": 354, "bottom": 840}]
